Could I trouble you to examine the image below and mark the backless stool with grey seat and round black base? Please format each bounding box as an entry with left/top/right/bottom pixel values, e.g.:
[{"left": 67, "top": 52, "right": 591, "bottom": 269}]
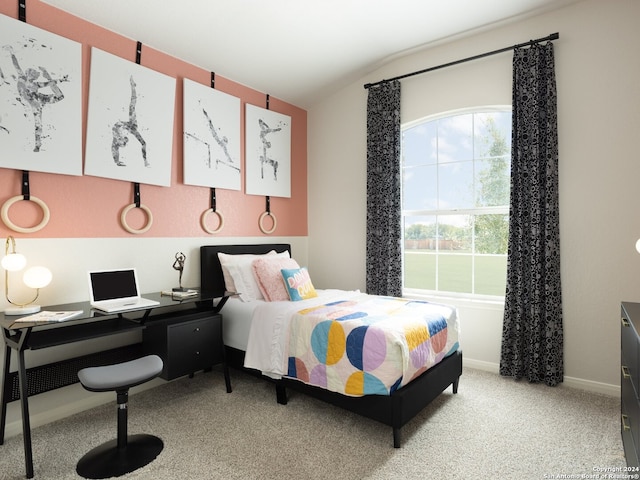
[{"left": 76, "top": 355, "right": 164, "bottom": 478}]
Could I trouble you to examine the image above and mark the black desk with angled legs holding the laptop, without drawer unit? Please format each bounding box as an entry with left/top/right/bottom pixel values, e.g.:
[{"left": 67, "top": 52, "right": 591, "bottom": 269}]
[{"left": 0, "top": 292, "right": 231, "bottom": 478}]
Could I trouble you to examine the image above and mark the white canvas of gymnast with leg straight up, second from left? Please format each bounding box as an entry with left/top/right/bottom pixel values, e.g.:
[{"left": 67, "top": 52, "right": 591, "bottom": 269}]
[{"left": 84, "top": 47, "right": 176, "bottom": 187}]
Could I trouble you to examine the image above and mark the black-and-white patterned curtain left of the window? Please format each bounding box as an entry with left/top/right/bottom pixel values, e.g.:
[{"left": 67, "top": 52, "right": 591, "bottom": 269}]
[{"left": 366, "top": 81, "right": 402, "bottom": 297}]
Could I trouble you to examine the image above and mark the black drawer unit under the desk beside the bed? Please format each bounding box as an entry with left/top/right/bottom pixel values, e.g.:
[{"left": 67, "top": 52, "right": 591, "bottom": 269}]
[{"left": 143, "top": 312, "right": 224, "bottom": 380}]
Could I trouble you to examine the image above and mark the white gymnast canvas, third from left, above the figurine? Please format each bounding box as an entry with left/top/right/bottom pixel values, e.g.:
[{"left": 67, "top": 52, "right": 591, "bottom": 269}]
[{"left": 183, "top": 79, "right": 242, "bottom": 190}]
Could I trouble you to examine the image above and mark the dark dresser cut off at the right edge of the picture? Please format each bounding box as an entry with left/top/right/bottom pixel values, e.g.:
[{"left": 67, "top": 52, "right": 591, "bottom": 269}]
[{"left": 620, "top": 302, "right": 640, "bottom": 467}]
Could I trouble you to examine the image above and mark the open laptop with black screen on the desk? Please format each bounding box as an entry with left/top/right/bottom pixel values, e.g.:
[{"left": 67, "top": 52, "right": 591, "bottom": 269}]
[{"left": 89, "top": 268, "right": 160, "bottom": 313}]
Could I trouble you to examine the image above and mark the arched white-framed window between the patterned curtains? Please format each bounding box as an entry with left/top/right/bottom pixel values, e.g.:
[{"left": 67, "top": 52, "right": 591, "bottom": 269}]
[{"left": 402, "top": 107, "right": 511, "bottom": 296}]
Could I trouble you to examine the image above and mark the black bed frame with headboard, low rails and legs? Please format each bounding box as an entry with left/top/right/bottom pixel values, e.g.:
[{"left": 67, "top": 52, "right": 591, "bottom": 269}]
[{"left": 200, "top": 243, "right": 462, "bottom": 448}]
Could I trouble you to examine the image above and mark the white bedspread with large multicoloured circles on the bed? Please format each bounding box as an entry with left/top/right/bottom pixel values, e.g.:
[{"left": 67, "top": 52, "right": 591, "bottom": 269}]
[{"left": 245, "top": 291, "right": 458, "bottom": 396}]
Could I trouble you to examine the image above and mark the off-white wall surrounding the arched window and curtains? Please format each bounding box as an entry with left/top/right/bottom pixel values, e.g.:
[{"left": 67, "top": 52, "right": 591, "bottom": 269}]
[{"left": 308, "top": 0, "right": 640, "bottom": 394}]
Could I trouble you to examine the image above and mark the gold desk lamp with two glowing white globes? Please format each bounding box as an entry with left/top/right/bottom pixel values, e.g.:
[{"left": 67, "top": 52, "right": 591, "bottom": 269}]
[{"left": 1, "top": 235, "right": 51, "bottom": 315}]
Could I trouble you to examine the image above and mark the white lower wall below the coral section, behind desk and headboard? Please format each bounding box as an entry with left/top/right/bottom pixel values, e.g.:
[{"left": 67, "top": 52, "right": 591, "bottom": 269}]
[{"left": 0, "top": 235, "right": 308, "bottom": 437}]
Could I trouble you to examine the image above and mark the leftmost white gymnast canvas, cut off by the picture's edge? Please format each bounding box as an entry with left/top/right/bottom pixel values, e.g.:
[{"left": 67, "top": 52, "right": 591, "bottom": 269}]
[{"left": 0, "top": 15, "right": 82, "bottom": 175}]
